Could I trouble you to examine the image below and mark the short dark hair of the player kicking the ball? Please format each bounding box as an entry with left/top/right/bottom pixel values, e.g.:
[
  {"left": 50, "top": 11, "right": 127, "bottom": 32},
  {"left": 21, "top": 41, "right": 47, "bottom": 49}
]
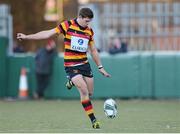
[{"left": 79, "top": 8, "right": 94, "bottom": 19}]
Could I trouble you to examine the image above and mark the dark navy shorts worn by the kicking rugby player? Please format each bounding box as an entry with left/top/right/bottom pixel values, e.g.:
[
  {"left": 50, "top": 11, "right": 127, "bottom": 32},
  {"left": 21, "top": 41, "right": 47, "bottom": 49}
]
[{"left": 65, "top": 63, "right": 93, "bottom": 79}]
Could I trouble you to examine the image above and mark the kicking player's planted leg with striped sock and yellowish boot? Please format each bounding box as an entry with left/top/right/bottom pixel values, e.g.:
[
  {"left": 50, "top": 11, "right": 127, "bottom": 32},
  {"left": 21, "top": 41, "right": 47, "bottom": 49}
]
[{"left": 71, "top": 74, "right": 100, "bottom": 128}]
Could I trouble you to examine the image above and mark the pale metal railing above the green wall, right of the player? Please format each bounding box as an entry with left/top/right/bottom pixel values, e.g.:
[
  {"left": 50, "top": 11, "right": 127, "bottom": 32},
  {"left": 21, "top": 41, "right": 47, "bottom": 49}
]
[{"left": 97, "top": 2, "right": 180, "bottom": 51}]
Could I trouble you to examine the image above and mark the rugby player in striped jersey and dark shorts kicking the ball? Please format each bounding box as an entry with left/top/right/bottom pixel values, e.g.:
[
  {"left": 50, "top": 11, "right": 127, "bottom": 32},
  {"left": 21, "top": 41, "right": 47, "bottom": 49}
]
[{"left": 17, "top": 8, "right": 110, "bottom": 129}]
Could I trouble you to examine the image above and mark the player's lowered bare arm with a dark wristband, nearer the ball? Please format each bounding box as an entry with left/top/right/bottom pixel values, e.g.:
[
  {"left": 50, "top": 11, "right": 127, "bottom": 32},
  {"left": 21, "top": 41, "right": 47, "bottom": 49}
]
[{"left": 89, "top": 44, "right": 111, "bottom": 77}]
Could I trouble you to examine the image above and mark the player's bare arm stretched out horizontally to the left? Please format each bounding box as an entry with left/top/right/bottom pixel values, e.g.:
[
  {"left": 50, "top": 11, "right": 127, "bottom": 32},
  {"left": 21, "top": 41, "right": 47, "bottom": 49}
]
[{"left": 17, "top": 28, "right": 57, "bottom": 40}]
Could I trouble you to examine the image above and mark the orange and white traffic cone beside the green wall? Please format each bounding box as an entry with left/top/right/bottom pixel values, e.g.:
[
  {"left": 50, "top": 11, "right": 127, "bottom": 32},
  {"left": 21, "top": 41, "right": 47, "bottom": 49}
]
[{"left": 19, "top": 67, "right": 28, "bottom": 99}]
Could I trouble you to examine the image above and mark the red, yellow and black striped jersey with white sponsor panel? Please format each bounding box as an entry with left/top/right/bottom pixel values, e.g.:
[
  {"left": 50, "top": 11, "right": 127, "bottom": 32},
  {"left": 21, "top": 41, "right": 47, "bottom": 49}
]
[{"left": 55, "top": 19, "right": 94, "bottom": 67}]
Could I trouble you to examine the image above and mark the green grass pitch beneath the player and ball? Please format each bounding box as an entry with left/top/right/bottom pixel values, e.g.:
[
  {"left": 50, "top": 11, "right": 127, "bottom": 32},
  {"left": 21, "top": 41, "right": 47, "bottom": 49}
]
[{"left": 0, "top": 100, "right": 180, "bottom": 133}]
